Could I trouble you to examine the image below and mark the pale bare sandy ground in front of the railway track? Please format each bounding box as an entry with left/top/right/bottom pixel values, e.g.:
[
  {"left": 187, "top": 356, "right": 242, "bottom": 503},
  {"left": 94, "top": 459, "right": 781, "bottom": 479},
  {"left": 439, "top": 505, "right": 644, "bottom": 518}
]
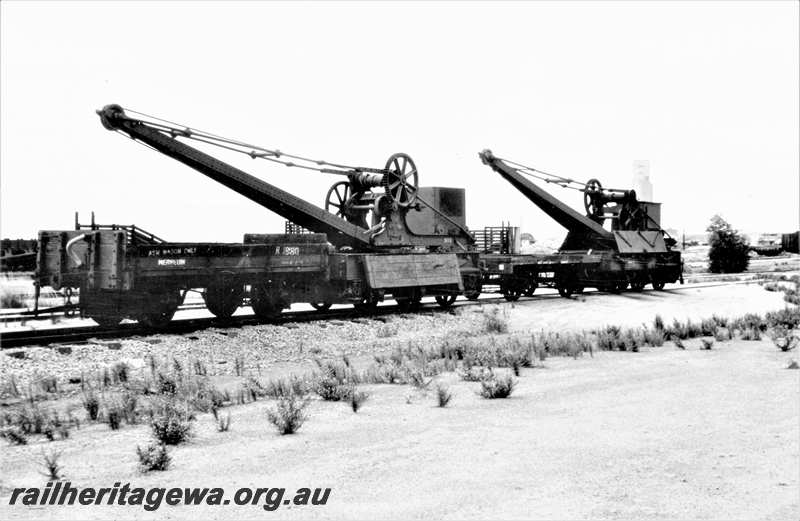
[{"left": 0, "top": 284, "right": 800, "bottom": 520}]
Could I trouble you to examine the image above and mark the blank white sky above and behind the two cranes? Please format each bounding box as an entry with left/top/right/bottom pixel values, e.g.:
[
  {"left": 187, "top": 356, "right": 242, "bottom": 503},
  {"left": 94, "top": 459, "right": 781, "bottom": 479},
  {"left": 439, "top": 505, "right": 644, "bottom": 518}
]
[{"left": 0, "top": 1, "right": 800, "bottom": 241}]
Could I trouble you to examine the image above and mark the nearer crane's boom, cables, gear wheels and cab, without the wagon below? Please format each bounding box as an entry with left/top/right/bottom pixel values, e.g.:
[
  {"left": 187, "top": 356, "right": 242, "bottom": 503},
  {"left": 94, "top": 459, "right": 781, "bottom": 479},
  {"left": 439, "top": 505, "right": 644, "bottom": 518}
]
[{"left": 97, "top": 105, "right": 473, "bottom": 252}]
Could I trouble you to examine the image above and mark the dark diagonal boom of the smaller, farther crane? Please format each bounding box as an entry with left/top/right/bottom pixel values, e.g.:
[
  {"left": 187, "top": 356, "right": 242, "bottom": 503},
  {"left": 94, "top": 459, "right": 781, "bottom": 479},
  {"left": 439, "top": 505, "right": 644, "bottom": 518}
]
[{"left": 479, "top": 150, "right": 614, "bottom": 240}]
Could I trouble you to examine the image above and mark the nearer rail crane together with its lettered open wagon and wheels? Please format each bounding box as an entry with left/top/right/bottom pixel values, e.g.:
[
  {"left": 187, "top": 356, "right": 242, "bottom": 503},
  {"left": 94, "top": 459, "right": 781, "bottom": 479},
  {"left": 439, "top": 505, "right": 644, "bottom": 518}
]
[{"left": 35, "top": 105, "right": 480, "bottom": 327}]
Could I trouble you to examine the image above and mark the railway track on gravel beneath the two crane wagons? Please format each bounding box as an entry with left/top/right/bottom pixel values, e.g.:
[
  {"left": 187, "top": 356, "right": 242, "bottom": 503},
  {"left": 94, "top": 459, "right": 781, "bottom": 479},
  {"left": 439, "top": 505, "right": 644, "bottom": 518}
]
[{"left": 0, "top": 279, "right": 780, "bottom": 349}]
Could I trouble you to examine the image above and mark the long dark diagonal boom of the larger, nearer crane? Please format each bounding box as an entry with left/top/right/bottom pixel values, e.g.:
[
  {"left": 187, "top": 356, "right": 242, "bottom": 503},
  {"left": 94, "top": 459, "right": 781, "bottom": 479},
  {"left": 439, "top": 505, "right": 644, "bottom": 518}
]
[{"left": 98, "top": 105, "right": 370, "bottom": 248}]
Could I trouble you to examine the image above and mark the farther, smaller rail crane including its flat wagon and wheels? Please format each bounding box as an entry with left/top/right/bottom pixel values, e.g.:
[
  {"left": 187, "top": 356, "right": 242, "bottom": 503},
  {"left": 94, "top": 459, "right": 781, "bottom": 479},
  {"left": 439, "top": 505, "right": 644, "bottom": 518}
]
[{"left": 479, "top": 150, "right": 682, "bottom": 296}]
